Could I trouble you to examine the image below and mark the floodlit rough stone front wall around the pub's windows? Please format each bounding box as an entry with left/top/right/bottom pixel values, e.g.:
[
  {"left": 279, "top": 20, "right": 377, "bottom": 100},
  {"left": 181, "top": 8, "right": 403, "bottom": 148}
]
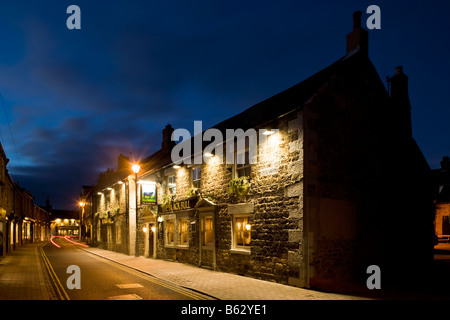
[{"left": 157, "top": 112, "right": 303, "bottom": 283}]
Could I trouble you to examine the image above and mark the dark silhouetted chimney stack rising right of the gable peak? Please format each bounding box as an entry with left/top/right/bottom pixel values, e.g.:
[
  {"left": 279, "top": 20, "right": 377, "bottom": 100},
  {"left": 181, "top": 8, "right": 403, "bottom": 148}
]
[{"left": 389, "top": 66, "right": 412, "bottom": 137}]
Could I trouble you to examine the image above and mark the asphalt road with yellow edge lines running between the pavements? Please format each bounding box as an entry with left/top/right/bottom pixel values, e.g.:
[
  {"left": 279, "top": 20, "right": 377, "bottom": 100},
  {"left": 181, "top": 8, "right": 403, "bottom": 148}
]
[{"left": 40, "top": 237, "right": 206, "bottom": 300}]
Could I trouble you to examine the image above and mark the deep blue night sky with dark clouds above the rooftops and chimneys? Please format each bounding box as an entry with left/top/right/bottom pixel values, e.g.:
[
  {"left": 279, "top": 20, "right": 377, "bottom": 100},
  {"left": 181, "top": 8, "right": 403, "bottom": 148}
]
[{"left": 0, "top": 0, "right": 450, "bottom": 209}]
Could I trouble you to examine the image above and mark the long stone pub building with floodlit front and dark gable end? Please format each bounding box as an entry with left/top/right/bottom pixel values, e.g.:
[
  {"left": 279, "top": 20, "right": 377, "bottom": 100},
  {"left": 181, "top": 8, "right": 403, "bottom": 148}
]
[{"left": 82, "top": 12, "right": 433, "bottom": 291}]
